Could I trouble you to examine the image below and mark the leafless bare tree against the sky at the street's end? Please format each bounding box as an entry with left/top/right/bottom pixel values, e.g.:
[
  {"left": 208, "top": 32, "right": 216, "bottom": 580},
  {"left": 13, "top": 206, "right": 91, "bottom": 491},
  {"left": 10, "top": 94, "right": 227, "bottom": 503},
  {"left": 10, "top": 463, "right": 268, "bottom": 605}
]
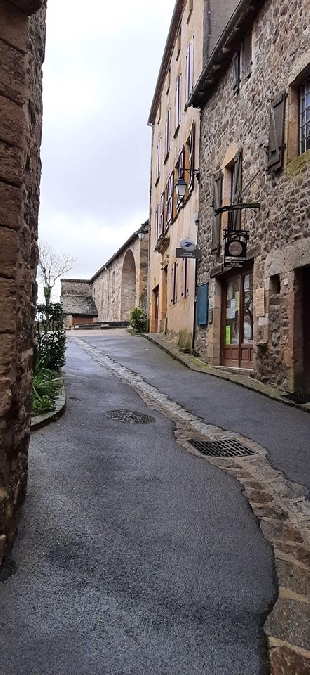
[{"left": 38, "top": 241, "right": 77, "bottom": 306}]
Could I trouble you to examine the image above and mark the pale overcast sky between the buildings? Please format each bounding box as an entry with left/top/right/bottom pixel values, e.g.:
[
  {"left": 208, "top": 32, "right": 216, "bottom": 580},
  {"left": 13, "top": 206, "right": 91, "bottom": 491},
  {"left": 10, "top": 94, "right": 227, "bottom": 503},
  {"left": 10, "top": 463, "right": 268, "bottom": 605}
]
[{"left": 39, "top": 0, "right": 175, "bottom": 290}]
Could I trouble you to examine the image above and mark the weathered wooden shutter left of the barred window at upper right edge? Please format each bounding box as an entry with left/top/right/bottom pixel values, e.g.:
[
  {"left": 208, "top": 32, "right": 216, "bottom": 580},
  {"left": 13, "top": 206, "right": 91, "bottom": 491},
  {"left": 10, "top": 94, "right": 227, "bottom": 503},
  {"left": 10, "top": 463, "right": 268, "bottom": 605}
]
[{"left": 267, "top": 92, "right": 286, "bottom": 171}]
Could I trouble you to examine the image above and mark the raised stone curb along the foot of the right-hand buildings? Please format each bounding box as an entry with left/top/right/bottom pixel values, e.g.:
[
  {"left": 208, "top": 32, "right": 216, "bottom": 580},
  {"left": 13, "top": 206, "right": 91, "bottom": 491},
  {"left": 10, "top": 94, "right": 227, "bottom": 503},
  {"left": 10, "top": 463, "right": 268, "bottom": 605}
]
[{"left": 140, "top": 333, "right": 310, "bottom": 413}]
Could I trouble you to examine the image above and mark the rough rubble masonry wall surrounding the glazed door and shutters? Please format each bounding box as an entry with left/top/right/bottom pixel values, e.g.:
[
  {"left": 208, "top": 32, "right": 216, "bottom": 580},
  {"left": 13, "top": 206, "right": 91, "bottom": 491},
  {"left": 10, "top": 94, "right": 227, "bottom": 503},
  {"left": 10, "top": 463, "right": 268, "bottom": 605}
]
[{"left": 196, "top": 0, "right": 310, "bottom": 390}]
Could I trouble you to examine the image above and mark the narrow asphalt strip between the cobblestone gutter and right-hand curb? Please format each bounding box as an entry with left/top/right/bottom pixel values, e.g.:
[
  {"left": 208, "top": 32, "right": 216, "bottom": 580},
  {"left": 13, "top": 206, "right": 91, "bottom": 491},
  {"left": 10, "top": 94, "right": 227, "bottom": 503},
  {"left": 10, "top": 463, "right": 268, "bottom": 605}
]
[{"left": 83, "top": 332, "right": 310, "bottom": 493}]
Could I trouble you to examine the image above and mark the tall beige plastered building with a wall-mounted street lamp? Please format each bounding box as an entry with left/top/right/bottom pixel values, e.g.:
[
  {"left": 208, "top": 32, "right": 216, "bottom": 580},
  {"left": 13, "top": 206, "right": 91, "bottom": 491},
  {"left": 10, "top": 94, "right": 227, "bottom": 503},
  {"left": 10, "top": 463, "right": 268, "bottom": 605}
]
[{"left": 148, "top": 0, "right": 237, "bottom": 348}]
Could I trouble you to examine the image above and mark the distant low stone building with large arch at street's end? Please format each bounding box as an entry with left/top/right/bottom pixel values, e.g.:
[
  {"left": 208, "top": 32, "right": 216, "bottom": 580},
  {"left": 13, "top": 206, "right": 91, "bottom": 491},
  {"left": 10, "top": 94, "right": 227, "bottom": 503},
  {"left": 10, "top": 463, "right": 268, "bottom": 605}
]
[{"left": 61, "top": 221, "right": 149, "bottom": 326}]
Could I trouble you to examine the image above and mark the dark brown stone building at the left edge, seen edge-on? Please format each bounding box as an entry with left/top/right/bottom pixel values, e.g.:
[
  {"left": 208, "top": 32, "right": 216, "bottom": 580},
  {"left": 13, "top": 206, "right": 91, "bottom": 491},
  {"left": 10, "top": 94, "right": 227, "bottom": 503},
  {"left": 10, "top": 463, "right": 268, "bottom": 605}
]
[{"left": 0, "top": 0, "right": 45, "bottom": 563}]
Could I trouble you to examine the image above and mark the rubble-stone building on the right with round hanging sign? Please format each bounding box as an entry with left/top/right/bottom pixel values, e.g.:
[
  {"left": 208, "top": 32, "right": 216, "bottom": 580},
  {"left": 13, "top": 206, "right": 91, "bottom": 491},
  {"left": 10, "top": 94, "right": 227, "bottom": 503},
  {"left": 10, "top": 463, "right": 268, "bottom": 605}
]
[{"left": 190, "top": 0, "right": 310, "bottom": 394}]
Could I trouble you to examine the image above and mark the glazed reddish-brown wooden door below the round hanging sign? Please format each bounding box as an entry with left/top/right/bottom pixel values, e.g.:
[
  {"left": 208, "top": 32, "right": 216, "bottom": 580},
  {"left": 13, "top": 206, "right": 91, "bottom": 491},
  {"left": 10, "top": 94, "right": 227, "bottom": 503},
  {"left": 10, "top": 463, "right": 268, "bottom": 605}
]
[{"left": 222, "top": 271, "right": 253, "bottom": 369}]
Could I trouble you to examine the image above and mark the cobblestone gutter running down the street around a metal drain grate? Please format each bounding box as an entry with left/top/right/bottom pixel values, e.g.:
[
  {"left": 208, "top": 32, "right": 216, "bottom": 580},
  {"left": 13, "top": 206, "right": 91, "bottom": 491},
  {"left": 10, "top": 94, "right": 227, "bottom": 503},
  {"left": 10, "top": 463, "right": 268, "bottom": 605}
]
[{"left": 74, "top": 338, "right": 310, "bottom": 675}]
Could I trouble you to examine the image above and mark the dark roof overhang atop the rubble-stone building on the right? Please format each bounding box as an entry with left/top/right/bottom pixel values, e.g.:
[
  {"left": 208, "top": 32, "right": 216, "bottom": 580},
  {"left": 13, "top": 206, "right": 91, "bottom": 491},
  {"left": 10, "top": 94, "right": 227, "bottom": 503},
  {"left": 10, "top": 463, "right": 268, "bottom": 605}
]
[{"left": 188, "top": 0, "right": 265, "bottom": 108}]
